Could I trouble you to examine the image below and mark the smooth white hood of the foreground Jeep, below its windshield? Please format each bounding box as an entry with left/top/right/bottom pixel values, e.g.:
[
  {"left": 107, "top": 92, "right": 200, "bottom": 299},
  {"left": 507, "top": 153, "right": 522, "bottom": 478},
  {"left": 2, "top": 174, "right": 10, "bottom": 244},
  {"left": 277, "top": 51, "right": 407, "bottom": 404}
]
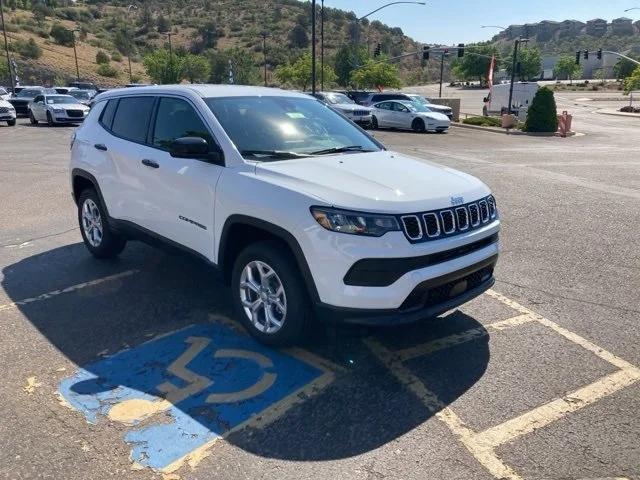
[{"left": 256, "top": 151, "right": 490, "bottom": 214}]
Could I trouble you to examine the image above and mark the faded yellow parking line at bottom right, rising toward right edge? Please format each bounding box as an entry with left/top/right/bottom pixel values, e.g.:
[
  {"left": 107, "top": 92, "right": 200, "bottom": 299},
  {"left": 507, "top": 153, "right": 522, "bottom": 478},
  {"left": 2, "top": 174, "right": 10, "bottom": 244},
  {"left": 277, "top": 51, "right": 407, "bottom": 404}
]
[{"left": 474, "top": 369, "right": 640, "bottom": 448}]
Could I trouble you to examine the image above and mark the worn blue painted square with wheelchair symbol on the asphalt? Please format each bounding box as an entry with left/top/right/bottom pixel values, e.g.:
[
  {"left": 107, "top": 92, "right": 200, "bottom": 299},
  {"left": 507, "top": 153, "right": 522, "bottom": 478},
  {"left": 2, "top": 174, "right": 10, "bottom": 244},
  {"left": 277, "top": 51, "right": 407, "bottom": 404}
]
[{"left": 59, "top": 324, "right": 325, "bottom": 470}]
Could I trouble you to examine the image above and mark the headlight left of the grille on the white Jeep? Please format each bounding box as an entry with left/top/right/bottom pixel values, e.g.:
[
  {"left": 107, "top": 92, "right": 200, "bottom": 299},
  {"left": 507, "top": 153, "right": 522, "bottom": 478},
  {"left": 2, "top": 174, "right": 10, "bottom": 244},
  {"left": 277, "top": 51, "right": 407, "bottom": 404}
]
[{"left": 311, "top": 207, "right": 400, "bottom": 237}]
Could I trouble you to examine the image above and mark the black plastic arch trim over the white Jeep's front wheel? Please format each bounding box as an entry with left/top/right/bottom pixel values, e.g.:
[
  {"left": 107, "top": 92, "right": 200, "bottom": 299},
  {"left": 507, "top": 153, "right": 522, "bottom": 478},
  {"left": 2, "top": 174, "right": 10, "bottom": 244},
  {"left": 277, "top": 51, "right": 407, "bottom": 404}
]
[{"left": 217, "top": 215, "right": 320, "bottom": 303}]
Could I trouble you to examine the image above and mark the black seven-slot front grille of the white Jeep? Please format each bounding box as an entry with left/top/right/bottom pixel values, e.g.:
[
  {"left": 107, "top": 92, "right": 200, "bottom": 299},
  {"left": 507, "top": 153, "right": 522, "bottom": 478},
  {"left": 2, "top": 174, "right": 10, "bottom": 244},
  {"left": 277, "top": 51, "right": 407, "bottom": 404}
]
[{"left": 400, "top": 196, "right": 498, "bottom": 243}]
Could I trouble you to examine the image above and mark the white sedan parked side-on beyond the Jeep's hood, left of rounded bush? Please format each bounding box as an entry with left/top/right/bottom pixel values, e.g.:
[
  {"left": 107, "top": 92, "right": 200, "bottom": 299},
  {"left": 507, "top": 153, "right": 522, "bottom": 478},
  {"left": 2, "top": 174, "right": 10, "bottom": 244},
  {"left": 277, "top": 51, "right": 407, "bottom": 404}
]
[{"left": 371, "top": 100, "right": 451, "bottom": 133}]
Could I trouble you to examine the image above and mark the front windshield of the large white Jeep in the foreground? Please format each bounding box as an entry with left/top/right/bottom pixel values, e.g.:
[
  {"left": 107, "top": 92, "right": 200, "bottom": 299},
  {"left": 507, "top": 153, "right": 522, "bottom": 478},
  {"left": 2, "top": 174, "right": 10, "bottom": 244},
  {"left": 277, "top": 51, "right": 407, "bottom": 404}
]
[{"left": 205, "top": 97, "right": 381, "bottom": 160}]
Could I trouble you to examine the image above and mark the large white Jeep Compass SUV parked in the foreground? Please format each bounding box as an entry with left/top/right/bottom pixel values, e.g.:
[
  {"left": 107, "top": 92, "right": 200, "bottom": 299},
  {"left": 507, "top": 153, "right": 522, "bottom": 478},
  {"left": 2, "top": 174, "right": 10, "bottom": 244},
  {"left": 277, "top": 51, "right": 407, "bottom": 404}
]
[{"left": 70, "top": 85, "right": 500, "bottom": 345}]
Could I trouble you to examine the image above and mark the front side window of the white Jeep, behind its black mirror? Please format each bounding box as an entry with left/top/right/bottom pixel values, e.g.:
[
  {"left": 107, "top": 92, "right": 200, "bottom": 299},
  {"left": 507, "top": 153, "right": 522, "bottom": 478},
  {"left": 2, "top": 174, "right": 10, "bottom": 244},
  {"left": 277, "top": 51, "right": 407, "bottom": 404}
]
[{"left": 152, "top": 97, "right": 213, "bottom": 150}]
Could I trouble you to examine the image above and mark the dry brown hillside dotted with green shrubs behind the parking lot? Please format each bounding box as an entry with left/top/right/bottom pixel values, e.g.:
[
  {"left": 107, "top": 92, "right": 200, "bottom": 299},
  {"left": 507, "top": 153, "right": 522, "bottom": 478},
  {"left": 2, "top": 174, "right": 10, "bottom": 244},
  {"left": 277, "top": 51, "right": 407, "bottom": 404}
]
[{"left": 0, "top": 0, "right": 430, "bottom": 86}]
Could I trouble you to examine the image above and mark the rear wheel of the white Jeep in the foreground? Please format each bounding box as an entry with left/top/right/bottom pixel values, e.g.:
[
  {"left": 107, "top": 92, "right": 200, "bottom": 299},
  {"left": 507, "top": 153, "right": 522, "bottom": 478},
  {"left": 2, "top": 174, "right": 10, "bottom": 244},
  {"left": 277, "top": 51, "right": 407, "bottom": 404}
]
[{"left": 78, "top": 188, "right": 127, "bottom": 258}]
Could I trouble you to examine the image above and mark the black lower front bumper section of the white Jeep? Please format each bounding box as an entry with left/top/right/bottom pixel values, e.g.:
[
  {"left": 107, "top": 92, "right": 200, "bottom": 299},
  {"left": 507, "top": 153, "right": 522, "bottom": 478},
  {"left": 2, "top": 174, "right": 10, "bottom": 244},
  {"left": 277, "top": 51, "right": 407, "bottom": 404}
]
[{"left": 315, "top": 255, "right": 498, "bottom": 326}]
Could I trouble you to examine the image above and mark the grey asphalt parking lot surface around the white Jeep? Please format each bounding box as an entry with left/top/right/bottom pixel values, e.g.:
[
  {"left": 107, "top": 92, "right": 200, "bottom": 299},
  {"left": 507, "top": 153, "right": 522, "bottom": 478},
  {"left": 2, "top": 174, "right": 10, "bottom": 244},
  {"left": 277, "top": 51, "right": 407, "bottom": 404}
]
[{"left": 0, "top": 95, "right": 640, "bottom": 480}]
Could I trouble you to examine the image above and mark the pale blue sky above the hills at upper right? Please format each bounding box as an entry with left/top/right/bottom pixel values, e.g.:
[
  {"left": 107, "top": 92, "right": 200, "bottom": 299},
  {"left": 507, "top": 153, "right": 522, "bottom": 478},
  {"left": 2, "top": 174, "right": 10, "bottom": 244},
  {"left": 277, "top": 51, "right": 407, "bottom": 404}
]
[{"left": 317, "top": 0, "right": 640, "bottom": 45}]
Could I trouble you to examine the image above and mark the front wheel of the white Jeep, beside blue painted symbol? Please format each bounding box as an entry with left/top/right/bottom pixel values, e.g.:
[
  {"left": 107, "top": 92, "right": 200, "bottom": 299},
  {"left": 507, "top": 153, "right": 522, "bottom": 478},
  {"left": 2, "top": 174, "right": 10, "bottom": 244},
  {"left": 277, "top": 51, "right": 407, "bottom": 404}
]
[{"left": 231, "top": 241, "right": 312, "bottom": 347}]
